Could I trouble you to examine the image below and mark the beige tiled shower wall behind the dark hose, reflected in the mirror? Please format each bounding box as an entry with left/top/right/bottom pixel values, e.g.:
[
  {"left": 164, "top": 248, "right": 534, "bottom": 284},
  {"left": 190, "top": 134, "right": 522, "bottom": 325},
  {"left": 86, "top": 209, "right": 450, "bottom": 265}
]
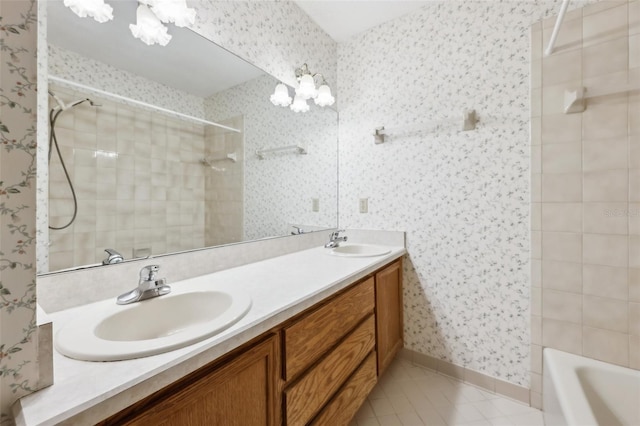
[{"left": 47, "top": 86, "right": 208, "bottom": 272}]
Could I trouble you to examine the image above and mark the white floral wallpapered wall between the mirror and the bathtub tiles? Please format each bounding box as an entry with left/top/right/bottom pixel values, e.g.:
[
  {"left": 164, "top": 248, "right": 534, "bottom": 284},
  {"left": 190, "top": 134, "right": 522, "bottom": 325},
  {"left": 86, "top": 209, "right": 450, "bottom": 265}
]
[{"left": 338, "top": 1, "right": 592, "bottom": 387}]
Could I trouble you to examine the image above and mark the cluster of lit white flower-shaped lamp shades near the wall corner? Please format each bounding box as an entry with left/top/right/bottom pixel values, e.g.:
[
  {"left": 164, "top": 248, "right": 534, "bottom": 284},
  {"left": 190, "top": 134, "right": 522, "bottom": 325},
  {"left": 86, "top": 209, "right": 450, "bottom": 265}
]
[{"left": 271, "top": 64, "right": 336, "bottom": 112}]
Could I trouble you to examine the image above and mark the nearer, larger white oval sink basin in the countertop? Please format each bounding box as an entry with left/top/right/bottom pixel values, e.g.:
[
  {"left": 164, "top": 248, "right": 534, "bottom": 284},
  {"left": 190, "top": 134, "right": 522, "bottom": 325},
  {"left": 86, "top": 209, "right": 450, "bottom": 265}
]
[{"left": 54, "top": 289, "right": 251, "bottom": 361}]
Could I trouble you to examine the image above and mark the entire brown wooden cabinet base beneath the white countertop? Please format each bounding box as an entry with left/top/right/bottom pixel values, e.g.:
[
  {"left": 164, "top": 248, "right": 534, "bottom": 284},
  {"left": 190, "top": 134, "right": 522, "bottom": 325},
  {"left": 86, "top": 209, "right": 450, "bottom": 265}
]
[{"left": 100, "top": 260, "right": 403, "bottom": 426}]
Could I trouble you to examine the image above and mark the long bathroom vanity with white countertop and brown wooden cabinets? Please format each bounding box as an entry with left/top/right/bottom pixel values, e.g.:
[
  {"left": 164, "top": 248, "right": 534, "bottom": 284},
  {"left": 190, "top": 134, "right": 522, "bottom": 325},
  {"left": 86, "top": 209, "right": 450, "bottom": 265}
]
[{"left": 14, "top": 236, "right": 405, "bottom": 426}]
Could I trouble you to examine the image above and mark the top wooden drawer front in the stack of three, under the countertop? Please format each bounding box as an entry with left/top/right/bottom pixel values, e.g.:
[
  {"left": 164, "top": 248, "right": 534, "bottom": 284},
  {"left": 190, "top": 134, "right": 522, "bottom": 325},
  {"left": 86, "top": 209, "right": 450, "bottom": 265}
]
[{"left": 283, "top": 277, "right": 375, "bottom": 380}]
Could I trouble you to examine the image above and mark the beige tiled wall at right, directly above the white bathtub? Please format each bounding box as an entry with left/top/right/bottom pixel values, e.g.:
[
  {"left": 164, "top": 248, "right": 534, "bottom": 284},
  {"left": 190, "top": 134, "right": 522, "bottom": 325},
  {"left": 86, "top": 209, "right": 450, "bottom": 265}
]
[{"left": 531, "top": 0, "right": 640, "bottom": 410}]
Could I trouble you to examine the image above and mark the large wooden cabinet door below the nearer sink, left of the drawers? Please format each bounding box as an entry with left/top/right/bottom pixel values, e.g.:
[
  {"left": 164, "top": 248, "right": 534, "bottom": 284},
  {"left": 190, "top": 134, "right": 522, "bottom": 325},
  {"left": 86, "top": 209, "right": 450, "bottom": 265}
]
[{"left": 103, "top": 336, "right": 279, "bottom": 426}]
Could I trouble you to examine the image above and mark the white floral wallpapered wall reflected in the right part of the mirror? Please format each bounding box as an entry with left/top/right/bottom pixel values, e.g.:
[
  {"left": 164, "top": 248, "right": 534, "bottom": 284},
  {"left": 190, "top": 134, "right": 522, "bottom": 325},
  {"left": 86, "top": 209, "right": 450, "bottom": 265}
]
[{"left": 205, "top": 75, "right": 338, "bottom": 240}]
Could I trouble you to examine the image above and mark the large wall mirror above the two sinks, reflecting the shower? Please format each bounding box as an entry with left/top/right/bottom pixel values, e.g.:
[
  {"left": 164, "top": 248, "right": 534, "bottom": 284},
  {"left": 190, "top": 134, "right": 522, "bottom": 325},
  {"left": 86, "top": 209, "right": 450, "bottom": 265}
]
[{"left": 38, "top": 0, "right": 338, "bottom": 274}]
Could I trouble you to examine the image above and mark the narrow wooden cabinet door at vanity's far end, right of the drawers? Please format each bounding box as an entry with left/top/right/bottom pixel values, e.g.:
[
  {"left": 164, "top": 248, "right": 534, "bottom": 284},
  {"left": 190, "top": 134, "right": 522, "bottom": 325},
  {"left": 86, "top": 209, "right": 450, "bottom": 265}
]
[{"left": 376, "top": 260, "right": 403, "bottom": 376}]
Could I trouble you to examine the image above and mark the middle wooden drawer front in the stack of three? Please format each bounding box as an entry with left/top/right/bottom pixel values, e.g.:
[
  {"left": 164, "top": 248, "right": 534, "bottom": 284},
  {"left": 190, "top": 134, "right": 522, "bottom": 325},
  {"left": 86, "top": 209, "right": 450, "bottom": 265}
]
[{"left": 284, "top": 315, "right": 375, "bottom": 426}]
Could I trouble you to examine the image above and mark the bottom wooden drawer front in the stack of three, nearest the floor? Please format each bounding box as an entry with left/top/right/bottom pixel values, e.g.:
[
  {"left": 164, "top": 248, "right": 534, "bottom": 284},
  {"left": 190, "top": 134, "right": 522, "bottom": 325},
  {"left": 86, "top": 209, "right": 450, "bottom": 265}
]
[{"left": 311, "top": 352, "right": 377, "bottom": 426}]
